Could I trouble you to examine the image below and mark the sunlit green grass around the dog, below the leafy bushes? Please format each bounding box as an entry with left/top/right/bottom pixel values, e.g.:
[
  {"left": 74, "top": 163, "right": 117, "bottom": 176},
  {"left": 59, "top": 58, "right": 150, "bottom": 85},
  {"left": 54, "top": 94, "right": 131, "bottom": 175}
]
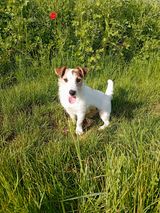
[{"left": 0, "top": 56, "right": 160, "bottom": 213}]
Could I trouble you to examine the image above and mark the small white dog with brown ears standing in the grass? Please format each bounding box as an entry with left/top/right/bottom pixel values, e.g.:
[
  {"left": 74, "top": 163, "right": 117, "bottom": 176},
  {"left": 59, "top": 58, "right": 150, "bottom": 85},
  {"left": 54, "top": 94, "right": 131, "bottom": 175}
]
[{"left": 55, "top": 66, "right": 113, "bottom": 135}]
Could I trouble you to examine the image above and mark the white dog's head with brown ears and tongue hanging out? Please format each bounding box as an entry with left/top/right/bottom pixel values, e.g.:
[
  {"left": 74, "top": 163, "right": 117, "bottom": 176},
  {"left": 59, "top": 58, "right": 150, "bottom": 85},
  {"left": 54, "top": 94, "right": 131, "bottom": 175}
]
[{"left": 55, "top": 67, "right": 87, "bottom": 104}]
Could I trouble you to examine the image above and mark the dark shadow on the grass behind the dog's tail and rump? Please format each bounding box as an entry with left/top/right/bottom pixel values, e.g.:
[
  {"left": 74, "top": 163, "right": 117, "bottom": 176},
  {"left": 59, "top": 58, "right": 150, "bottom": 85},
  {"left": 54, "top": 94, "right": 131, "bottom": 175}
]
[{"left": 112, "top": 88, "right": 143, "bottom": 120}]
